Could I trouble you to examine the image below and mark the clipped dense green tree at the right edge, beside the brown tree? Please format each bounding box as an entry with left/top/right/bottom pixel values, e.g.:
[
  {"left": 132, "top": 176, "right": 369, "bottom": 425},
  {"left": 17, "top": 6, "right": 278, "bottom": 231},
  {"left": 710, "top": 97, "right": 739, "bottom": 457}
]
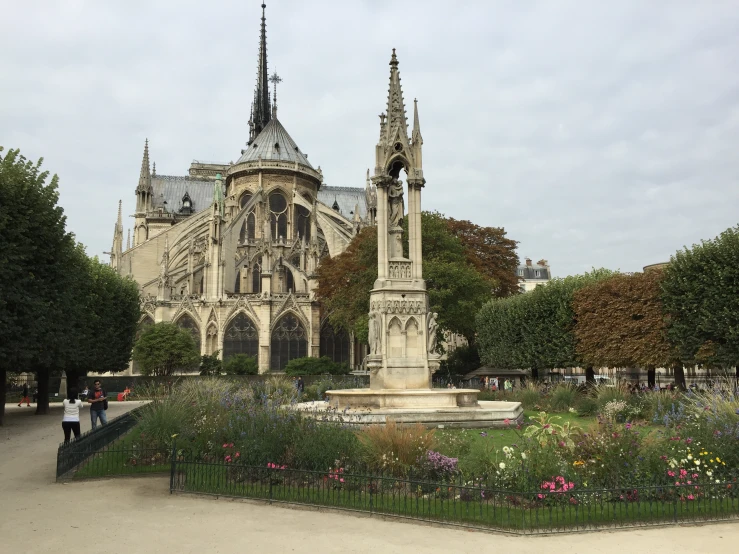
[{"left": 662, "top": 226, "right": 739, "bottom": 378}]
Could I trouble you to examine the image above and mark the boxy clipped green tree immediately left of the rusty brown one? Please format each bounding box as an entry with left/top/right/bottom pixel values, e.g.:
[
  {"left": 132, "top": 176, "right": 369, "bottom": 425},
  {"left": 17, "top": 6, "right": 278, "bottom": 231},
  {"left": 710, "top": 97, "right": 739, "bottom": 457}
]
[{"left": 477, "top": 269, "right": 612, "bottom": 381}]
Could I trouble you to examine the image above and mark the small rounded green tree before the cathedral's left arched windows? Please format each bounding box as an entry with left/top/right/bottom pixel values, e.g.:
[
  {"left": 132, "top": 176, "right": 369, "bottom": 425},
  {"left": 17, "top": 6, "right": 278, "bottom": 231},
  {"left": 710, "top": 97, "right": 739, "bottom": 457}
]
[{"left": 133, "top": 322, "right": 200, "bottom": 377}]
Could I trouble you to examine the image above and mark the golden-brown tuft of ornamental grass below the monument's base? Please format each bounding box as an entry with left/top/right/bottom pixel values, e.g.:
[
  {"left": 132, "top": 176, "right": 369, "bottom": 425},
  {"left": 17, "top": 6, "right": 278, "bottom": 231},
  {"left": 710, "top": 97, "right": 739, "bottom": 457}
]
[{"left": 357, "top": 420, "right": 436, "bottom": 476}]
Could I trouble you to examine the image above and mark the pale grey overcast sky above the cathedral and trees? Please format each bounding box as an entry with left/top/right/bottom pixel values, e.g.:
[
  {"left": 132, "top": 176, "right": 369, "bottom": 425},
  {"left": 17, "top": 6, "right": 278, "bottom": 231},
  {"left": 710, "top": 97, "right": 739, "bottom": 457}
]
[{"left": 0, "top": 0, "right": 739, "bottom": 276}]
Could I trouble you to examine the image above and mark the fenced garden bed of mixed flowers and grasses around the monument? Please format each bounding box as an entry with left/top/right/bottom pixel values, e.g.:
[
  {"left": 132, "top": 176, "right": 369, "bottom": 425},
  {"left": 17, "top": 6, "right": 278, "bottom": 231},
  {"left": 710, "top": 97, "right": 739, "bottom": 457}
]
[{"left": 65, "top": 377, "right": 739, "bottom": 532}]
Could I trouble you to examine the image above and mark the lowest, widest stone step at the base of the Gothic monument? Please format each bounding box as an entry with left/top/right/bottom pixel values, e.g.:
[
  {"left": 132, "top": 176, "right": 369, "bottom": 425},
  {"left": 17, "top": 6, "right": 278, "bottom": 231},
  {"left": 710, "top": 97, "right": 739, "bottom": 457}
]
[{"left": 295, "top": 398, "right": 523, "bottom": 429}]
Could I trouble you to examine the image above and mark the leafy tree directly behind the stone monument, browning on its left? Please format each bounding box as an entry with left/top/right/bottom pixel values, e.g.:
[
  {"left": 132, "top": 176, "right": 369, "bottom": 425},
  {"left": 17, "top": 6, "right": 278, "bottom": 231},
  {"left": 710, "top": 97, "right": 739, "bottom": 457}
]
[{"left": 317, "top": 212, "right": 506, "bottom": 343}]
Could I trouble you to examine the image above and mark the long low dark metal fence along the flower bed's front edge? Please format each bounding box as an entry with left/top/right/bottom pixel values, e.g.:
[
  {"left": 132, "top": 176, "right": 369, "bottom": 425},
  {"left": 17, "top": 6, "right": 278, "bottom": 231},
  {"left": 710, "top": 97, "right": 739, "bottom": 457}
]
[{"left": 170, "top": 450, "right": 739, "bottom": 534}]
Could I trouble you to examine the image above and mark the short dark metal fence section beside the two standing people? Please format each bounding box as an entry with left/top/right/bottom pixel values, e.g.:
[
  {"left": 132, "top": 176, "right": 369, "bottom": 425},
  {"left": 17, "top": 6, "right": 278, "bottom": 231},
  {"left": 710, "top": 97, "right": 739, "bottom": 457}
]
[{"left": 56, "top": 408, "right": 141, "bottom": 481}]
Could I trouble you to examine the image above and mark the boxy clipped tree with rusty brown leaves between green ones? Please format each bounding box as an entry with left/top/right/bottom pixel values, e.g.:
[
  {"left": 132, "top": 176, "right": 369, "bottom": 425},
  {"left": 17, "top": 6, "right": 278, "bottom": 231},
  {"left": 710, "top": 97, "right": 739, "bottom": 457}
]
[{"left": 573, "top": 270, "right": 684, "bottom": 386}]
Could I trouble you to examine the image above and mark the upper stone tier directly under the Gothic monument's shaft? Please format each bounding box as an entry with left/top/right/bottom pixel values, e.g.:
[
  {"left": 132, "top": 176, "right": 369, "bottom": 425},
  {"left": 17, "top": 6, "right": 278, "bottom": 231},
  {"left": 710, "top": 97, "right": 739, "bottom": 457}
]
[{"left": 326, "top": 389, "right": 479, "bottom": 410}]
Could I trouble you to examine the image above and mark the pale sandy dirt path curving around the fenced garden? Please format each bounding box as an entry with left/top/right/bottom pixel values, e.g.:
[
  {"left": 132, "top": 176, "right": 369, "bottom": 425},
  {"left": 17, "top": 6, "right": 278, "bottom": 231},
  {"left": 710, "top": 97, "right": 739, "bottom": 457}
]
[{"left": 0, "top": 402, "right": 739, "bottom": 554}]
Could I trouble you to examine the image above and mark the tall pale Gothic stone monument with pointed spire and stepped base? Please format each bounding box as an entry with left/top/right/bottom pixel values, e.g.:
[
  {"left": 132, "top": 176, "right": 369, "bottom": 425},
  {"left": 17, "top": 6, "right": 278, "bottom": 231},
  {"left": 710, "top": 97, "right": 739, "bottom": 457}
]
[{"left": 326, "top": 49, "right": 522, "bottom": 426}]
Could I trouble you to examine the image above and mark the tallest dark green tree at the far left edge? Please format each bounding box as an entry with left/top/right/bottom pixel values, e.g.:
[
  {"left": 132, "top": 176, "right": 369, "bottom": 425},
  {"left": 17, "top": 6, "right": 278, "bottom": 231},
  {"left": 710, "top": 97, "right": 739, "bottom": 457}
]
[{"left": 0, "top": 147, "right": 74, "bottom": 418}]
